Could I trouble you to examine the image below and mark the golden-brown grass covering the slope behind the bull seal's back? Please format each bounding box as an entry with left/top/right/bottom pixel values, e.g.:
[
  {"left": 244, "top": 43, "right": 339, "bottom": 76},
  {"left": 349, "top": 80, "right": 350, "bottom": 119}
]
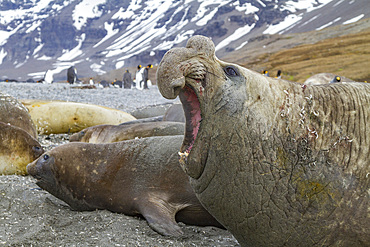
[{"left": 243, "top": 31, "right": 370, "bottom": 83}]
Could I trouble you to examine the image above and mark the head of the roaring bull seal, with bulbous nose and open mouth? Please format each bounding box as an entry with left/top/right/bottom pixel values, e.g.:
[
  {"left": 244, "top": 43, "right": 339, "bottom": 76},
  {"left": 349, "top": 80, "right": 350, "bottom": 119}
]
[{"left": 157, "top": 36, "right": 246, "bottom": 179}]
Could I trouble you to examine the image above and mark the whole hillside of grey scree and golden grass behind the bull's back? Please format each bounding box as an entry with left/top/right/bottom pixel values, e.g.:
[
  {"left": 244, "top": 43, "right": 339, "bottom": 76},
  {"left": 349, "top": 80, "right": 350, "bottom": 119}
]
[{"left": 224, "top": 19, "right": 370, "bottom": 82}]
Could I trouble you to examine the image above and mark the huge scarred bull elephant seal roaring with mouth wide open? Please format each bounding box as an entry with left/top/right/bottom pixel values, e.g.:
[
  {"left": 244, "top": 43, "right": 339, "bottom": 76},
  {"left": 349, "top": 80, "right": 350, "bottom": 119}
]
[{"left": 157, "top": 36, "right": 370, "bottom": 246}]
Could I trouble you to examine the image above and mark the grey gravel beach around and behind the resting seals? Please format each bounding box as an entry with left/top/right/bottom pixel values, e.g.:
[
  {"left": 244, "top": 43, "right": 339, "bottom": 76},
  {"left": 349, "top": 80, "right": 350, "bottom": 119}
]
[{"left": 0, "top": 82, "right": 238, "bottom": 247}]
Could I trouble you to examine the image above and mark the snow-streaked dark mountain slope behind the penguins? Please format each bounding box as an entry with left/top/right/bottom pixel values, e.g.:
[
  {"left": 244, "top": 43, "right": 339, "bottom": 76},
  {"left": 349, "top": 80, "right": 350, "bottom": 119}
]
[{"left": 0, "top": 0, "right": 370, "bottom": 80}]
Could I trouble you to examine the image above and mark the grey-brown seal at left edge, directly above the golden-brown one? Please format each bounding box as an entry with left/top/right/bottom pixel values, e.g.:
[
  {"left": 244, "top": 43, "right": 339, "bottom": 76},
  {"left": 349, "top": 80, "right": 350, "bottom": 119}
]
[{"left": 0, "top": 93, "right": 37, "bottom": 138}]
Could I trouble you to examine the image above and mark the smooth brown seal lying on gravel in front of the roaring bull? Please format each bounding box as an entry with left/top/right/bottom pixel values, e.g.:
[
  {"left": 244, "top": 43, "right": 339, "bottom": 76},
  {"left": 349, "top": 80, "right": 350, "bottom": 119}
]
[{"left": 27, "top": 136, "right": 222, "bottom": 236}]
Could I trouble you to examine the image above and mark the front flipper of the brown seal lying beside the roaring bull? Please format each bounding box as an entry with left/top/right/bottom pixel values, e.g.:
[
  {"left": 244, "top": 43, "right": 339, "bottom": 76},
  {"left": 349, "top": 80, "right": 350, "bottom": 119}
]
[{"left": 140, "top": 199, "right": 183, "bottom": 236}]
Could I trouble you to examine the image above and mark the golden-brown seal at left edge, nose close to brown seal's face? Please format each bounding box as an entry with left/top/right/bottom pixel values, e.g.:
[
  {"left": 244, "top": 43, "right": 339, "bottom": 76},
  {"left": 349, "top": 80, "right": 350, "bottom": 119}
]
[{"left": 0, "top": 122, "right": 44, "bottom": 175}]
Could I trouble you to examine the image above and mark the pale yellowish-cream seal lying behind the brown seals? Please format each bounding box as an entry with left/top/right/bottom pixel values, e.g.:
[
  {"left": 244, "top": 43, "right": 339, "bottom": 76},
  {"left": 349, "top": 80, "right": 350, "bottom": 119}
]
[{"left": 22, "top": 100, "right": 136, "bottom": 134}]
